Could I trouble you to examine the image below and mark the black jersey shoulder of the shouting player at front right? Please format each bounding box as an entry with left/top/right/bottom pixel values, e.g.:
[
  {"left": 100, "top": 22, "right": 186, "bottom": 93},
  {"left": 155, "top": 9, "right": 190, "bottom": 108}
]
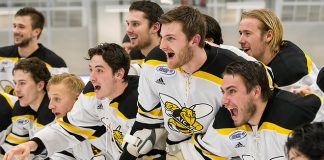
[{"left": 264, "top": 89, "right": 321, "bottom": 130}]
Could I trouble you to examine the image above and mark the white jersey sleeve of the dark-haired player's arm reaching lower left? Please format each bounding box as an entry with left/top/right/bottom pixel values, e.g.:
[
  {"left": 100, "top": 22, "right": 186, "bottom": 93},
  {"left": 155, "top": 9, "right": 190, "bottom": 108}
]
[{"left": 35, "top": 92, "right": 106, "bottom": 156}]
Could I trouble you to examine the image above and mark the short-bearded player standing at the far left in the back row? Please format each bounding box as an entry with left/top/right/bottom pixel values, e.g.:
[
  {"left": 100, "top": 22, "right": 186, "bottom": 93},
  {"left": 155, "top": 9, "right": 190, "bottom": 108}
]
[{"left": 0, "top": 7, "right": 68, "bottom": 95}]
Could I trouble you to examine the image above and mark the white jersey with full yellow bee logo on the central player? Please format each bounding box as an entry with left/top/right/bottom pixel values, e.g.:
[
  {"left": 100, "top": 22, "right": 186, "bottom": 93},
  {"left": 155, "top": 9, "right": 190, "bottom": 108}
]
[{"left": 132, "top": 44, "right": 244, "bottom": 144}]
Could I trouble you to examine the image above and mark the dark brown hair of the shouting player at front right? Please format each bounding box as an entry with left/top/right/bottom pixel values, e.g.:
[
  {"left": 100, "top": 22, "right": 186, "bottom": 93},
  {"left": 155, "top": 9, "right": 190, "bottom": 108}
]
[{"left": 224, "top": 61, "right": 273, "bottom": 101}]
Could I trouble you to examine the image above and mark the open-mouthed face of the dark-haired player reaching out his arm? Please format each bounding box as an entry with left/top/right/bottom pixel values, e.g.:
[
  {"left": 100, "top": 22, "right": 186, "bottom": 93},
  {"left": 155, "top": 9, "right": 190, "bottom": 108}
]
[{"left": 89, "top": 55, "right": 117, "bottom": 99}]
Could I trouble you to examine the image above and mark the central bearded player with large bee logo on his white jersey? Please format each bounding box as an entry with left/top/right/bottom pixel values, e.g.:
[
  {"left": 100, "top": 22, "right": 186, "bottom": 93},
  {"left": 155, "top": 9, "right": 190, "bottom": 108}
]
[{"left": 121, "top": 6, "right": 248, "bottom": 160}]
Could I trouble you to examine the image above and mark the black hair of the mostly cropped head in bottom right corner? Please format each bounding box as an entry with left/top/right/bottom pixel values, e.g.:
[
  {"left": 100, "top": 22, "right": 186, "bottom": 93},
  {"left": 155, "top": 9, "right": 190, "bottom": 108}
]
[{"left": 286, "top": 122, "right": 324, "bottom": 160}]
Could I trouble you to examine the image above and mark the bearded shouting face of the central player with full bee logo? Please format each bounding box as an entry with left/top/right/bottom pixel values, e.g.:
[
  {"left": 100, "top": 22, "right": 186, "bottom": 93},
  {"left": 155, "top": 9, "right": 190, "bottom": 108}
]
[{"left": 160, "top": 22, "right": 193, "bottom": 69}]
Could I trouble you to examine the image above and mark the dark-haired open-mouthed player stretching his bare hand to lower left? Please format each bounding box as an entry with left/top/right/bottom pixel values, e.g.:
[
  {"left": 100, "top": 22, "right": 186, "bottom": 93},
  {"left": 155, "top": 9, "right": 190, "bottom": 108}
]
[{"left": 4, "top": 43, "right": 165, "bottom": 159}]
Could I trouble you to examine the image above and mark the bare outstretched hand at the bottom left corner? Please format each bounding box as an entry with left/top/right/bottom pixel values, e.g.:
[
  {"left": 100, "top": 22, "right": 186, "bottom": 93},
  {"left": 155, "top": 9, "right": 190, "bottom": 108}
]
[{"left": 3, "top": 141, "right": 38, "bottom": 160}]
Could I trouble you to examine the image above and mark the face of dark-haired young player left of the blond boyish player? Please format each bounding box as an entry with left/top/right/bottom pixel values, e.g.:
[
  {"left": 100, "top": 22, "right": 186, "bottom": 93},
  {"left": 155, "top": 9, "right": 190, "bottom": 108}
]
[{"left": 13, "top": 70, "right": 45, "bottom": 107}]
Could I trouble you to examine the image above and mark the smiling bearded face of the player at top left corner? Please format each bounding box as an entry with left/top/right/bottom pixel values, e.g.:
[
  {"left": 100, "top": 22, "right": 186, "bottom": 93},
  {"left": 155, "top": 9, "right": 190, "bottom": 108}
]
[{"left": 13, "top": 16, "right": 40, "bottom": 47}]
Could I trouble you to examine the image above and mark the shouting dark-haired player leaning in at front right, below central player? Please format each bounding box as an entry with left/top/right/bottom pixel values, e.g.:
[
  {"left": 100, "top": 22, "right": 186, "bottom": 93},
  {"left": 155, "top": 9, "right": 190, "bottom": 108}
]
[{"left": 189, "top": 61, "right": 321, "bottom": 160}]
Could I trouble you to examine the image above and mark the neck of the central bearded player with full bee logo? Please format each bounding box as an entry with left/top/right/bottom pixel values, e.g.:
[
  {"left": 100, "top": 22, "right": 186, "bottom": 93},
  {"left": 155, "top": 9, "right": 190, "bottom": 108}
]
[{"left": 181, "top": 47, "right": 207, "bottom": 74}]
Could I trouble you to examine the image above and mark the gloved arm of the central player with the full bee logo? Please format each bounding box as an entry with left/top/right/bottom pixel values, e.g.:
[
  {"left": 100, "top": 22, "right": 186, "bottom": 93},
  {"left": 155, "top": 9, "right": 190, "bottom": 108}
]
[{"left": 120, "top": 60, "right": 166, "bottom": 160}]
